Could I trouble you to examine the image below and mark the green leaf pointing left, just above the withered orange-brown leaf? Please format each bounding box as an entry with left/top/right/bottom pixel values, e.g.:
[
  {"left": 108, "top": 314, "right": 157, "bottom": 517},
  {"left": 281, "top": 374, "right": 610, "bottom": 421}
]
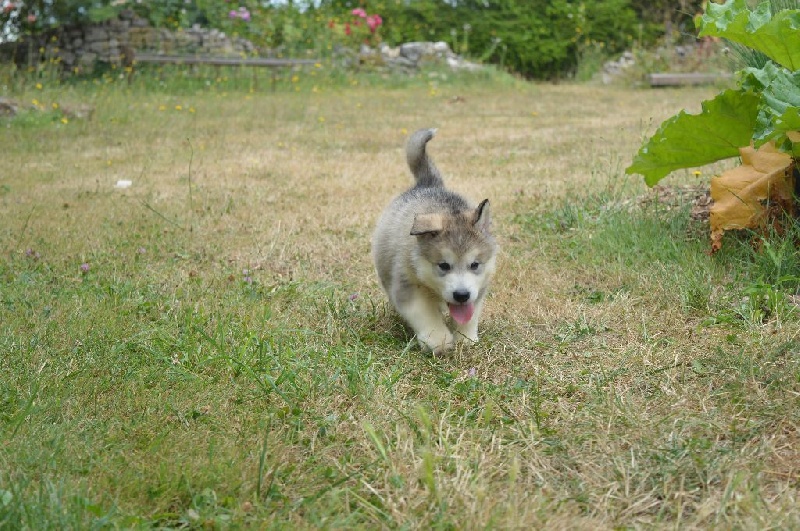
[{"left": 625, "top": 89, "right": 759, "bottom": 186}]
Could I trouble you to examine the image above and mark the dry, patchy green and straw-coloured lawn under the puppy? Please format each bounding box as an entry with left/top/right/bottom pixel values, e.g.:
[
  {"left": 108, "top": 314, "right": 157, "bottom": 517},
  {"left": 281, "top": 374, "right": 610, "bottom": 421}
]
[{"left": 0, "top": 68, "right": 800, "bottom": 529}]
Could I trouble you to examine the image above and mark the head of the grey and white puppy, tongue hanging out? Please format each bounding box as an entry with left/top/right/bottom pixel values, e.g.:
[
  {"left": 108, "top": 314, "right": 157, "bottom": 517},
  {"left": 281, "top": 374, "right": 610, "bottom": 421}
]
[{"left": 411, "top": 199, "right": 497, "bottom": 324}]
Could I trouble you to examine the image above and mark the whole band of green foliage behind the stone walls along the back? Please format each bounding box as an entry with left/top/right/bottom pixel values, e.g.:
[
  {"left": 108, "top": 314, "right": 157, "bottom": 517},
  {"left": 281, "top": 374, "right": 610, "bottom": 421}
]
[{"left": 0, "top": 0, "right": 701, "bottom": 78}]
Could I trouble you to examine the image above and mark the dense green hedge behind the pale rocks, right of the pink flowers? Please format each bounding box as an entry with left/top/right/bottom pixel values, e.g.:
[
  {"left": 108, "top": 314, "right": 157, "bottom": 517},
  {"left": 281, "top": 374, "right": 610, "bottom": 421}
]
[{"left": 352, "top": 0, "right": 640, "bottom": 78}]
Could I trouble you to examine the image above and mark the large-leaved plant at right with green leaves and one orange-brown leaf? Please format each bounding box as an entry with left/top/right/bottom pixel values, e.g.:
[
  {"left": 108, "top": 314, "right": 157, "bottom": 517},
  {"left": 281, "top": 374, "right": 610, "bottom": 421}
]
[{"left": 626, "top": 0, "right": 800, "bottom": 251}]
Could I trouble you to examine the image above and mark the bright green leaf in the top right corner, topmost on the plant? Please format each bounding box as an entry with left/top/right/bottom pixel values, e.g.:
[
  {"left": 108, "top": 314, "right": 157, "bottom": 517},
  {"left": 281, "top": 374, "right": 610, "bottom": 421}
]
[{"left": 699, "top": 0, "right": 800, "bottom": 71}]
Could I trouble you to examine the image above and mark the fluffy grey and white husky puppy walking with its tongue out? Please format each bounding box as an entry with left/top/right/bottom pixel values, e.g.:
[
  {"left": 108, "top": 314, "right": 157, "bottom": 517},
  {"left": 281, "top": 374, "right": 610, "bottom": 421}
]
[{"left": 372, "top": 129, "right": 497, "bottom": 354}]
